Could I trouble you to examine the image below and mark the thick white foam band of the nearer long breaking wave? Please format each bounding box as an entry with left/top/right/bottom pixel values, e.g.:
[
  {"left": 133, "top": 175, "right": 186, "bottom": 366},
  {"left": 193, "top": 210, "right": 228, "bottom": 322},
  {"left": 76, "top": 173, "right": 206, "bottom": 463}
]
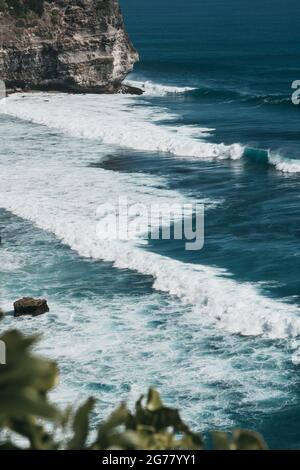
[{"left": 0, "top": 151, "right": 300, "bottom": 338}]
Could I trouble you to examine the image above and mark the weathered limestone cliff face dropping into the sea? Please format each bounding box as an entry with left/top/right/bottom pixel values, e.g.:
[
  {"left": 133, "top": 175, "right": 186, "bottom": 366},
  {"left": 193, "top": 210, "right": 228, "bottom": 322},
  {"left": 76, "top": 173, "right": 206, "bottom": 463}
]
[{"left": 0, "top": 0, "right": 138, "bottom": 93}]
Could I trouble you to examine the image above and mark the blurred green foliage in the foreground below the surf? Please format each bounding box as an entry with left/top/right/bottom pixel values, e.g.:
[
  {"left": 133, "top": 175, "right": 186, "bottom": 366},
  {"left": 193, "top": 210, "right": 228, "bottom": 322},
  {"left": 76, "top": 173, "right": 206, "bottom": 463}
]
[{"left": 0, "top": 324, "right": 266, "bottom": 450}]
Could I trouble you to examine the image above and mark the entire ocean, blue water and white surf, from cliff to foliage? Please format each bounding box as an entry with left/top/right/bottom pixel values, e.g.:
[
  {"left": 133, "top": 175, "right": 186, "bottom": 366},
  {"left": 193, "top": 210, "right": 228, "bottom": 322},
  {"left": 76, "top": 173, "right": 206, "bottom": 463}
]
[{"left": 0, "top": 0, "right": 300, "bottom": 449}]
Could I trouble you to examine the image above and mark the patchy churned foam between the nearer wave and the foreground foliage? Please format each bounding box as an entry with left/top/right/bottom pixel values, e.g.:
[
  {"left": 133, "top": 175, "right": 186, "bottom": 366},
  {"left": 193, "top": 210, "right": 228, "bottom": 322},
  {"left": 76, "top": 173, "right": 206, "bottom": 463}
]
[{"left": 1, "top": 292, "right": 293, "bottom": 429}]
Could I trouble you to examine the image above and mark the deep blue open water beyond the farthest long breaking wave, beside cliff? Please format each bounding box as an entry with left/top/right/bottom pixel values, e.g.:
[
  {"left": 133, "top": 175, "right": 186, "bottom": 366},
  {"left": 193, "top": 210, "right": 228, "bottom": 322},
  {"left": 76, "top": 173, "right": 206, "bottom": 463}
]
[{"left": 121, "top": 0, "right": 300, "bottom": 158}]
